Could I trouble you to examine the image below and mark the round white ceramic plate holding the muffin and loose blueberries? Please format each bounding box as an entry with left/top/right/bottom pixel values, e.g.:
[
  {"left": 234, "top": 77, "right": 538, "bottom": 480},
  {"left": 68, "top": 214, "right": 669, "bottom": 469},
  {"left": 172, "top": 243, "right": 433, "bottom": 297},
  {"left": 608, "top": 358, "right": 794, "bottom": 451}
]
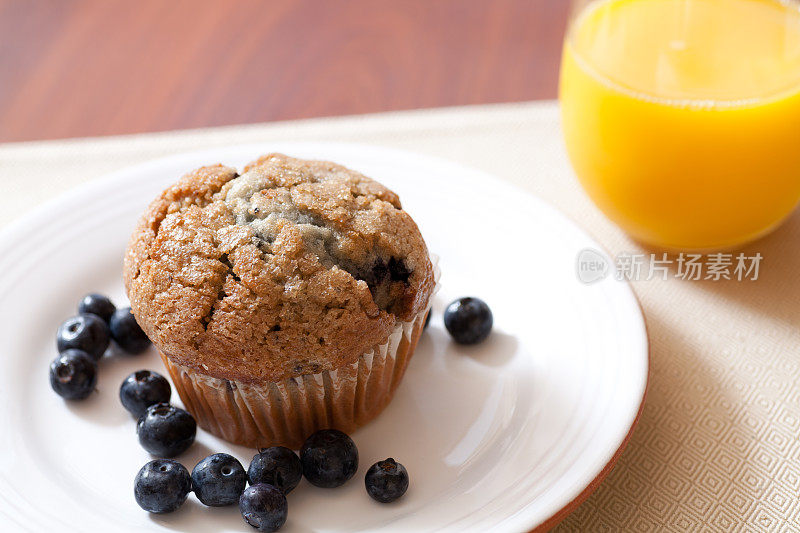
[{"left": 0, "top": 143, "right": 648, "bottom": 532}]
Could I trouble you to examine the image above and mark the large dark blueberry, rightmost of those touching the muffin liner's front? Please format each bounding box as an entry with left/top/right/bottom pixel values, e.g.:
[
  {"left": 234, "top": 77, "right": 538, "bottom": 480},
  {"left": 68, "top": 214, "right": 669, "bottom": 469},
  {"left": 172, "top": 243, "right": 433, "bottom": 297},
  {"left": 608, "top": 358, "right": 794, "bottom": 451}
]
[{"left": 300, "top": 429, "right": 358, "bottom": 488}]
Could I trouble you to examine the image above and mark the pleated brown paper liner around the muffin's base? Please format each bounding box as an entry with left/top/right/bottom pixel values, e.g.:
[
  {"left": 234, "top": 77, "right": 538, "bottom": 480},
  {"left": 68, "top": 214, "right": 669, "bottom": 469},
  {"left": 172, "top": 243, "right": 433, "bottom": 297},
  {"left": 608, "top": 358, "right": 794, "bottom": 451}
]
[{"left": 160, "top": 258, "right": 439, "bottom": 449}]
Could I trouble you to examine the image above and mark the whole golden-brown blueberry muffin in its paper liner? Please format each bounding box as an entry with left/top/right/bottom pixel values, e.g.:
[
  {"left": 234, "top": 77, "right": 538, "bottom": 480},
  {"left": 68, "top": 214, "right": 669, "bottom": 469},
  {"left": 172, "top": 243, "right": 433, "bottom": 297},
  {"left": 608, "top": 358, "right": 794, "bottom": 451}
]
[{"left": 124, "top": 154, "right": 435, "bottom": 448}]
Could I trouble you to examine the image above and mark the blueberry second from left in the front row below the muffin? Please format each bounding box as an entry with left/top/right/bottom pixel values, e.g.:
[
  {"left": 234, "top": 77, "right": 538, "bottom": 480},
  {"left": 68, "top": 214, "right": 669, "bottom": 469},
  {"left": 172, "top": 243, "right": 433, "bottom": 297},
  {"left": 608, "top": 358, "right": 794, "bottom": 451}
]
[{"left": 192, "top": 453, "right": 247, "bottom": 507}]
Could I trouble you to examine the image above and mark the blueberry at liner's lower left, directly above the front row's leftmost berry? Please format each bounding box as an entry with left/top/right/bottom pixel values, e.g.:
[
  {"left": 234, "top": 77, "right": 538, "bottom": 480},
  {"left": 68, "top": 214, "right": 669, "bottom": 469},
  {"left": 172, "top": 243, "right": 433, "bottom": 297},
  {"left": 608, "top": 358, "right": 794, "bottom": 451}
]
[{"left": 136, "top": 403, "right": 197, "bottom": 457}]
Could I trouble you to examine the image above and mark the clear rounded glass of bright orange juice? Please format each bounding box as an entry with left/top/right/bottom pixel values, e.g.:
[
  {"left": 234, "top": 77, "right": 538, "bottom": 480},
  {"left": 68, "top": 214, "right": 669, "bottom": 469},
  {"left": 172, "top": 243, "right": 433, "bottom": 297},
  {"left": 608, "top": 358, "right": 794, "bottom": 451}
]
[{"left": 560, "top": 0, "right": 800, "bottom": 249}]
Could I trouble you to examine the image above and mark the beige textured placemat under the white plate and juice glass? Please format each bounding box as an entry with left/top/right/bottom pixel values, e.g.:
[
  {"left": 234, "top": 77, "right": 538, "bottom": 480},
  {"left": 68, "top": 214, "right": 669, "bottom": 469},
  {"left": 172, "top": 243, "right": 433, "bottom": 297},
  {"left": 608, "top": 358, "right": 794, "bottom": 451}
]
[{"left": 0, "top": 102, "right": 800, "bottom": 531}]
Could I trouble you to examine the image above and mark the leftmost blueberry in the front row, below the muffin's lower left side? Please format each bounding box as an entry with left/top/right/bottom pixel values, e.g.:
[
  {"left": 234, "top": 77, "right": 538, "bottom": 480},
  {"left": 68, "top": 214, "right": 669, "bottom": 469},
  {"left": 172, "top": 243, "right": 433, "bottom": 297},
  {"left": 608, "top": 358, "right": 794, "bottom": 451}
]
[{"left": 133, "top": 459, "right": 192, "bottom": 513}]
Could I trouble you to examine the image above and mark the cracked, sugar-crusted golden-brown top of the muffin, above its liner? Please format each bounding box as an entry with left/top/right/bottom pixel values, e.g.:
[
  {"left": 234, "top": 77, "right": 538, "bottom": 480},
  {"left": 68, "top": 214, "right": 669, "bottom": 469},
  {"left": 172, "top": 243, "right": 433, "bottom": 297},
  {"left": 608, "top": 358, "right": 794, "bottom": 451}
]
[{"left": 124, "top": 154, "right": 434, "bottom": 383}]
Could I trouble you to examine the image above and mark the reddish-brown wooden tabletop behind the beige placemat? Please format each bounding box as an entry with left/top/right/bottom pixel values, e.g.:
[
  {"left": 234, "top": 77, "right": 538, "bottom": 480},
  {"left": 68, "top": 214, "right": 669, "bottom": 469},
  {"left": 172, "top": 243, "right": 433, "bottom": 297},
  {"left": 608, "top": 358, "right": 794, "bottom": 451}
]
[{"left": 0, "top": 0, "right": 568, "bottom": 141}]
